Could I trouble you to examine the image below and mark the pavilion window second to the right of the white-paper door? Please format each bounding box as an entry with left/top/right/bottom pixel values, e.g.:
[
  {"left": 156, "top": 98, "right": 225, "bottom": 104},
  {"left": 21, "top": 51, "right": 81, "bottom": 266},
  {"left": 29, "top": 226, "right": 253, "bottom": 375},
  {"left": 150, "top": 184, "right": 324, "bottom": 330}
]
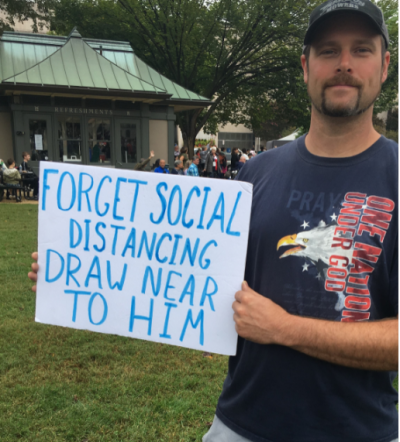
[{"left": 88, "top": 118, "right": 111, "bottom": 164}]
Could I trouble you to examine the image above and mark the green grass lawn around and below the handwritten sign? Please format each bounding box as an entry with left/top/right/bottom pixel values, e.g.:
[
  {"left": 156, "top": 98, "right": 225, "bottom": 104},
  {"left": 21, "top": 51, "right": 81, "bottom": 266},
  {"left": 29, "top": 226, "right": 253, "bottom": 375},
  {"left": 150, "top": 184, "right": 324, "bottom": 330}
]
[{"left": 0, "top": 204, "right": 227, "bottom": 442}]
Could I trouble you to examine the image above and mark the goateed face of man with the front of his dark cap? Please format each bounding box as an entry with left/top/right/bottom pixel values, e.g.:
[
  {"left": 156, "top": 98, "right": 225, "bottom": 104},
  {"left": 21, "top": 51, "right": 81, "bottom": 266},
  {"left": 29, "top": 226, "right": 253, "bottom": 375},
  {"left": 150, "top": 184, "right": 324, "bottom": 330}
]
[{"left": 301, "top": 13, "right": 390, "bottom": 117}]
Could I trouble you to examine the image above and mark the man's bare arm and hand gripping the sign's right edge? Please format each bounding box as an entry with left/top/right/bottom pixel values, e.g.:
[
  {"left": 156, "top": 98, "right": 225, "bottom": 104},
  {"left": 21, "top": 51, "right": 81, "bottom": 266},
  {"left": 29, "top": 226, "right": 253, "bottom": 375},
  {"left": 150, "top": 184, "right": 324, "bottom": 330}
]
[{"left": 232, "top": 282, "right": 398, "bottom": 371}]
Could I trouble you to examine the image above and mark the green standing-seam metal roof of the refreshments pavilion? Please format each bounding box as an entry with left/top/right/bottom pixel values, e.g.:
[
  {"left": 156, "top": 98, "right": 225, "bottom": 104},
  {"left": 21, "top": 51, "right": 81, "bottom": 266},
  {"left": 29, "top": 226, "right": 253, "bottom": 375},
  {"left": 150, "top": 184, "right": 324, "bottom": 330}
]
[{"left": 0, "top": 29, "right": 210, "bottom": 107}]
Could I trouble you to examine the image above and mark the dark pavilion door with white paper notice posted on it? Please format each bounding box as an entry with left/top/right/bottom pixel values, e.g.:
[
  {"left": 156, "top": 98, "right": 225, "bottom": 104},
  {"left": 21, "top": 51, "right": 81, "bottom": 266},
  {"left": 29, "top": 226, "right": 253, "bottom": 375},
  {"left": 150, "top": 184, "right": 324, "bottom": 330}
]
[{"left": 24, "top": 114, "right": 54, "bottom": 172}]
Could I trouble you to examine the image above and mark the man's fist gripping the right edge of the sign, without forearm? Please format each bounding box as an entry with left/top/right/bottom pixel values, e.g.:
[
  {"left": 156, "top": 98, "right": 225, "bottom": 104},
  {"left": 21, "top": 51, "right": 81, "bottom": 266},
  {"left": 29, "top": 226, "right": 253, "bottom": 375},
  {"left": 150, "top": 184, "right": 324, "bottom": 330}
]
[{"left": 232, "top": 281, "right": 291, "bottom": 344}]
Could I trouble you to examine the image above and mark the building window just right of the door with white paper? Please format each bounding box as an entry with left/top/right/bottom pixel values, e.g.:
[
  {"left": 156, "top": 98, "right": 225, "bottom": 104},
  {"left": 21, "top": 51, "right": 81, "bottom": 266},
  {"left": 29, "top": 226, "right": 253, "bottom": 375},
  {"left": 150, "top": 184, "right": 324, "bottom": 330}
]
[{"left": 58, "top": 117, "right": 82, "bottom": 163}]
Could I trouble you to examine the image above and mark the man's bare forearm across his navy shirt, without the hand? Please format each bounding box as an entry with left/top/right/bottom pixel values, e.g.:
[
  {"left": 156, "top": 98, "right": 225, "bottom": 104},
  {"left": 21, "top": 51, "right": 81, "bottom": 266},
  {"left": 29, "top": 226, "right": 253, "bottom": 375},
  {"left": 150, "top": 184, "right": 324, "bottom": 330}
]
[{"left": 278, "top": 315, "right": 398, "bottom": 370}]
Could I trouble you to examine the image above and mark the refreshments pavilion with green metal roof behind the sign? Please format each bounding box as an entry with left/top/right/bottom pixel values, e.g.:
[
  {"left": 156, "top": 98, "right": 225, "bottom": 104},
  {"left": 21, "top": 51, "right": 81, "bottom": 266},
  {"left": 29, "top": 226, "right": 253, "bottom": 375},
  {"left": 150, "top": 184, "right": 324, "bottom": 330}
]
[{"left": 0, "top": 29, "right": 211, "bottom": 169}]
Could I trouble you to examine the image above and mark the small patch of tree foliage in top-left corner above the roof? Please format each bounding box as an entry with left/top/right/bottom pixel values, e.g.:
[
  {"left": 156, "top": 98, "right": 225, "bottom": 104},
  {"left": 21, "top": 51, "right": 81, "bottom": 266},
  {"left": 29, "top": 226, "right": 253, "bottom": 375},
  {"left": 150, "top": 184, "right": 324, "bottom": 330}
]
[{"left": 0, "top": 0, "right": 53, "bottom": 35}]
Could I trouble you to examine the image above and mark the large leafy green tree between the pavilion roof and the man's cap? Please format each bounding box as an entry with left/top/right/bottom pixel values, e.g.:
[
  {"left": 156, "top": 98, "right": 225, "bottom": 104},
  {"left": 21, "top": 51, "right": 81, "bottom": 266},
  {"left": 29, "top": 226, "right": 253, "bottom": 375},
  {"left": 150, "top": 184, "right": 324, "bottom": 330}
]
[{"left": 52, "top": 0, "right": 316, "bottom": 154}]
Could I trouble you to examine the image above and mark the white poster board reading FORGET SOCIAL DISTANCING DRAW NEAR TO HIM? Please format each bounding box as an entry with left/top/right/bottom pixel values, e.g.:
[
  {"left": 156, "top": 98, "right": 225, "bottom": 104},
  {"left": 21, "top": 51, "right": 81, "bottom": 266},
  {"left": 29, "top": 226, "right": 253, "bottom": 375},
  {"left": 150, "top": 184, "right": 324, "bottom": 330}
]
[{"left": 36, "top": 162, "right": 252, "bottom": 355}]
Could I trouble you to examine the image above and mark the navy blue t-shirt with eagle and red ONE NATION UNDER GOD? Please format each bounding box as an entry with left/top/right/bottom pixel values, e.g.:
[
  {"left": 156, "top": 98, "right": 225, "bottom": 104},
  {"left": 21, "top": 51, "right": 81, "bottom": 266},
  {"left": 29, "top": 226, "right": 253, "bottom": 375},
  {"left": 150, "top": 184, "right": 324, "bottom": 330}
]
[{"left": 217, "top": 137, "right": 398, "bottom": 442}]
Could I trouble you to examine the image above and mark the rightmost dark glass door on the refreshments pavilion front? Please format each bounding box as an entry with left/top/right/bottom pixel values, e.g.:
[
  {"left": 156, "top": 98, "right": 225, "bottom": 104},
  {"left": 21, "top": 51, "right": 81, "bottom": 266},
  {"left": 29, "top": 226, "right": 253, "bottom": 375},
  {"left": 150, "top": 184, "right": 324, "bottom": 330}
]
[{"left": 115, "top": 118, "right": 142, "bottom": 169}]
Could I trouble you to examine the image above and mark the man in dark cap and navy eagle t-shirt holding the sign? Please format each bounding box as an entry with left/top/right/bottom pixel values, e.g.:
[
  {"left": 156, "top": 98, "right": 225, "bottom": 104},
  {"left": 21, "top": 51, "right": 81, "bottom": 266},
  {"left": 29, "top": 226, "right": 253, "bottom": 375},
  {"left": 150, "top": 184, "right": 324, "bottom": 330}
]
[{"left": 203, "top": 0, "right": 398, "bottom": 442}]
